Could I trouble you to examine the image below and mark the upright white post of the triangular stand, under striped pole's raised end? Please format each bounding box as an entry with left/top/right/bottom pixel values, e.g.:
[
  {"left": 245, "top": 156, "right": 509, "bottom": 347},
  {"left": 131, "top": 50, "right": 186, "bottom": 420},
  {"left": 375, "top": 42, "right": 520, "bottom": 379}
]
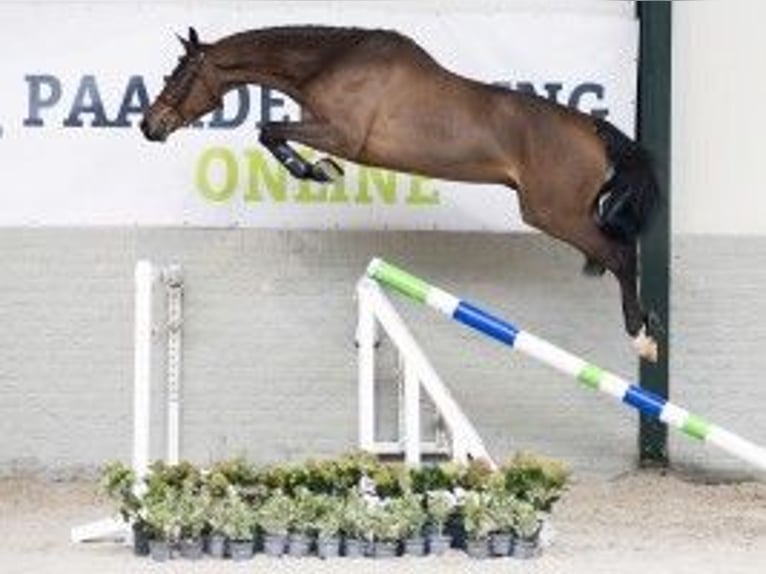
[{"left": 356, "top": 284, "right": 375, "bottom": 451}]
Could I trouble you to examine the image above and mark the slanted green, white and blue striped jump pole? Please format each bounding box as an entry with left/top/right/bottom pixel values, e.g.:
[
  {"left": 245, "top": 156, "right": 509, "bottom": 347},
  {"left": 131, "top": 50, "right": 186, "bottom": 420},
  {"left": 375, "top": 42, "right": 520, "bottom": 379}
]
[{"left": 367, "top": 259, "right": 766, "bottom": 470}]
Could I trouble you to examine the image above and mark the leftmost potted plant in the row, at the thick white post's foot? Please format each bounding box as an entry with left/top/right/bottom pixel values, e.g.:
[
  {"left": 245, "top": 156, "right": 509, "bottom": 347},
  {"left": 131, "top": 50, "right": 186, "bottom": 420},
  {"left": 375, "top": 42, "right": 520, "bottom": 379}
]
[{"left": 99, "top": 461, "right": 150, "bottom": 556}]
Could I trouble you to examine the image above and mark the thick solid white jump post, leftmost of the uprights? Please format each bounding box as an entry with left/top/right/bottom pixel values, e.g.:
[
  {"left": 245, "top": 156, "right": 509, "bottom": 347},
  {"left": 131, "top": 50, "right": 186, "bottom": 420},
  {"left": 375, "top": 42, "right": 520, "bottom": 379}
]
[{"left": 133, "top": 261, "right": 154, "bottom": 483}]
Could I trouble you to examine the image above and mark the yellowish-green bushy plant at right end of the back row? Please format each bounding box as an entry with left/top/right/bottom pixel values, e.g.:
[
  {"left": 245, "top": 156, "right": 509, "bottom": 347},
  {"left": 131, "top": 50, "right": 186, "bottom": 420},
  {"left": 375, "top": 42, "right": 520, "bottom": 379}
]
[{"left": 501, "top": 453, "right": 569, "bottom": 512}]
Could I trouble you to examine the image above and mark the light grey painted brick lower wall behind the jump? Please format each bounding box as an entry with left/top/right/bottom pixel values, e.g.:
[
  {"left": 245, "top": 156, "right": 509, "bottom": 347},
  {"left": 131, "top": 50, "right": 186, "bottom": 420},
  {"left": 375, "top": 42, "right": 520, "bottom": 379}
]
[{"left": 0, "top": 229, "right": 766, "bottom": 482}]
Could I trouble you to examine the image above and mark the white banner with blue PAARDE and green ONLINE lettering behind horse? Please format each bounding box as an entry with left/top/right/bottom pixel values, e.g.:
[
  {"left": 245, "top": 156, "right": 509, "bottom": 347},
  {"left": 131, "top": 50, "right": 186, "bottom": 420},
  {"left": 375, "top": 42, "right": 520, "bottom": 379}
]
[{"left": 0, "top": 2, "right": 638, "bottom": 231}]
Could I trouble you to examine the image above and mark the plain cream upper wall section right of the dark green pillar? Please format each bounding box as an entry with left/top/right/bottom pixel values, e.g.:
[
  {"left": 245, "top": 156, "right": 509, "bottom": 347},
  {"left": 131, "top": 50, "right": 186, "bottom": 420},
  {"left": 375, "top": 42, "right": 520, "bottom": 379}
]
[{"left": 673, "top": 0, "right": 766, "bottom": 235}]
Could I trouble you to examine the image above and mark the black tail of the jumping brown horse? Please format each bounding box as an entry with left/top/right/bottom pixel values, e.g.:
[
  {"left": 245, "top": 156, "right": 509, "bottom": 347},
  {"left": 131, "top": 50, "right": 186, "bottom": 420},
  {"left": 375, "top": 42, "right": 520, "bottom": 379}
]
[{"left": 594, "top": 119, "right": 660, "bottom": 241}]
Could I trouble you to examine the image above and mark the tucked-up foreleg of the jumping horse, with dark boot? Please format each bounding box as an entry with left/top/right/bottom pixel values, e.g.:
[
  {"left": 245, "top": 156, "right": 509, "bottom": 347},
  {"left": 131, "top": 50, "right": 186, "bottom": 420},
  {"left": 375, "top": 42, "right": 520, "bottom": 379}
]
[{"left": 259, "top": 122, "right": 350, "bottom": 183}]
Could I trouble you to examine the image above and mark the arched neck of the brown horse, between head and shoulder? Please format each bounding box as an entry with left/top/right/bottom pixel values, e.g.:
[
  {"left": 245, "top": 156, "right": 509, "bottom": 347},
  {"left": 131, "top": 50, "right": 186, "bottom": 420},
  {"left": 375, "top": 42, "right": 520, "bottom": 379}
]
[{"left": 212, "top": 30, "right": 354, "bottom": 96}]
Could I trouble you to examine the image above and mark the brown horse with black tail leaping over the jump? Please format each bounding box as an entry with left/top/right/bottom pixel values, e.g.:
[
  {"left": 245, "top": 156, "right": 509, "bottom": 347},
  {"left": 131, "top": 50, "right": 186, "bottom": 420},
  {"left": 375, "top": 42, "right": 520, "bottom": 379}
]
[{"left": 141, "top": 26, "right": 658, "bottom": 360}]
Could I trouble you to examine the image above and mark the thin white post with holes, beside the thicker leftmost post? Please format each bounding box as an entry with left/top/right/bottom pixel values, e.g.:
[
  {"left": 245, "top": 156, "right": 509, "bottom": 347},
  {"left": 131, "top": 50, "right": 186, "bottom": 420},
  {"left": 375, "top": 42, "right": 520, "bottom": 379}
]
[{"left": 163, "top": 265, "right": 183, "bottom": 464}]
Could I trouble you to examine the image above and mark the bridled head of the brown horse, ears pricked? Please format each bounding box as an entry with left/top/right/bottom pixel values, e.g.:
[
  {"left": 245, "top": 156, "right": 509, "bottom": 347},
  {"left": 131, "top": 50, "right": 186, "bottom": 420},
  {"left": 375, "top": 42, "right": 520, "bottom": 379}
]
[{"left": 141, "top": 28, "right": 222, "bottom": 141}]
